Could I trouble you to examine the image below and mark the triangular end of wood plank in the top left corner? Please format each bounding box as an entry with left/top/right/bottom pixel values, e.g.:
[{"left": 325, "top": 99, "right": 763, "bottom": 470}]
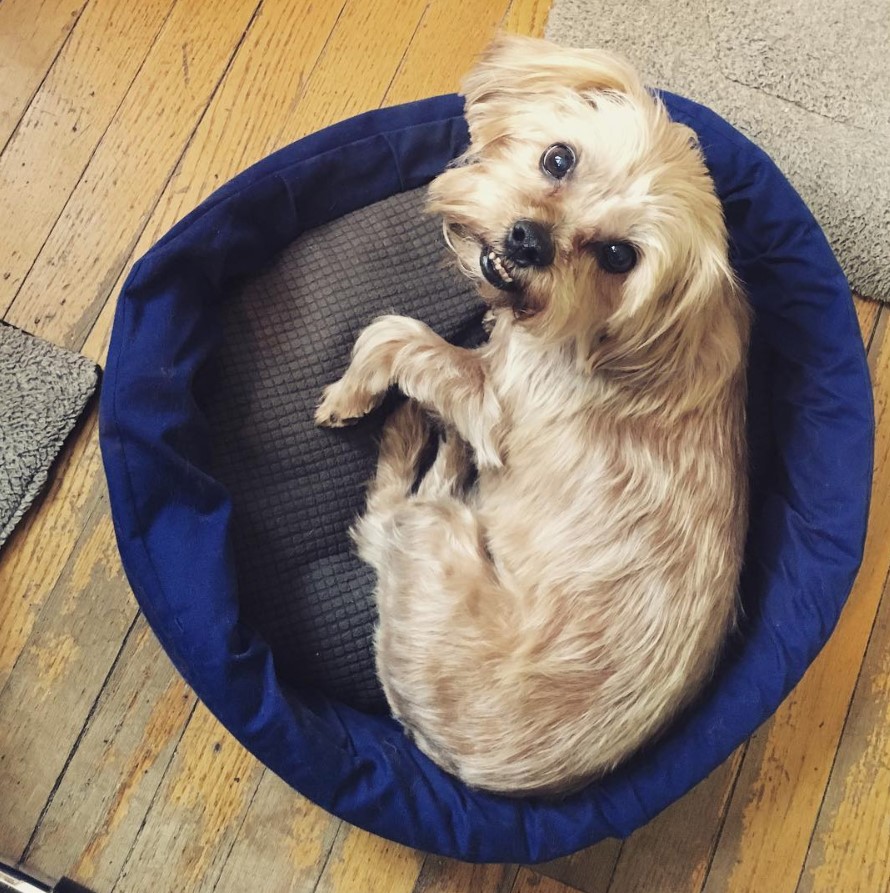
[{"left": 0, "top": 0, "right": 87, "bottom": 150}]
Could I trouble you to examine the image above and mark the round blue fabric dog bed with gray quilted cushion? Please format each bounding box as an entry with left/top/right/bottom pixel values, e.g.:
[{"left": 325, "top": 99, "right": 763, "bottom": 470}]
[{"left": 101, "top": 94, "right": 874, "bottom": 862}]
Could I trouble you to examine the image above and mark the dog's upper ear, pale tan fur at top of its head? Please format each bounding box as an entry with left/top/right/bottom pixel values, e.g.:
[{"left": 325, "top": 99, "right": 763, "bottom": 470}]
[{"left": 461, "top": 34, "right": 645, "bottom": 142}]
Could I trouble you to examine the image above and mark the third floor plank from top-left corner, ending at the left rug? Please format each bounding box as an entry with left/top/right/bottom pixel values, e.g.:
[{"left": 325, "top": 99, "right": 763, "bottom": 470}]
[{"left": 6, "top": 0, "right": 259, "bottom": 347}]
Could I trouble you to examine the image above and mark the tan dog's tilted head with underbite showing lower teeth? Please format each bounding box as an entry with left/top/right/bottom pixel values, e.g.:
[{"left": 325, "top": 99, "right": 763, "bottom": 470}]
[{"left": 430, "top": 38, "right": 733, "bottom": 362}]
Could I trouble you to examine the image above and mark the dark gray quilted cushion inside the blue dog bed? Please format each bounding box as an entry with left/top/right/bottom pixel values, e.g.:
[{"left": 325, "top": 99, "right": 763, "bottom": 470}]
[{"left": 199, "top": 189, "right": 482, "bottom": 710}]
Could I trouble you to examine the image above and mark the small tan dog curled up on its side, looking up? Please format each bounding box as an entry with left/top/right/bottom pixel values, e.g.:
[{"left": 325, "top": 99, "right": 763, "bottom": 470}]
[{"left": 316, "top": 38, "right": 749, "bottom": 794}]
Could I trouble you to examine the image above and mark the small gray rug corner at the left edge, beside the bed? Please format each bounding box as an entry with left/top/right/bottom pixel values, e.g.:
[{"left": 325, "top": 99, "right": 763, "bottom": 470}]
[{"left": 0, "top": 323, "right": 98, "bottom": 546}]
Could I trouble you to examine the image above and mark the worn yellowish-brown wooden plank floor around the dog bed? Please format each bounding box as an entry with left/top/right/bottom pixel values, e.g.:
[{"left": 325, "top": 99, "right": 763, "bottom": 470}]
[{"left": 0, "top": 0, "right": 890, "bottom": 893}]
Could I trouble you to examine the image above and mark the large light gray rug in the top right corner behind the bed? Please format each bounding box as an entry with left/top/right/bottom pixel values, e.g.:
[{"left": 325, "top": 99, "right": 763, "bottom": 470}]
[{"left": 547, "top": 0, "right": 890, "bottom": 300}]
